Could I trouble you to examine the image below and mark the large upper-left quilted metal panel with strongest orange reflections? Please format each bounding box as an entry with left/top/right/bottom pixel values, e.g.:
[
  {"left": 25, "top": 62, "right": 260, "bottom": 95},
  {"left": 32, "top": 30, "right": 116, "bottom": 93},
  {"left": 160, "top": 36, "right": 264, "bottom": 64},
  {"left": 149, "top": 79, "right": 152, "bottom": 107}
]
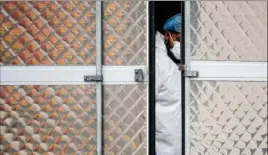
[{"left": 0, "top": 1, "right": 96, "bottom": 65}]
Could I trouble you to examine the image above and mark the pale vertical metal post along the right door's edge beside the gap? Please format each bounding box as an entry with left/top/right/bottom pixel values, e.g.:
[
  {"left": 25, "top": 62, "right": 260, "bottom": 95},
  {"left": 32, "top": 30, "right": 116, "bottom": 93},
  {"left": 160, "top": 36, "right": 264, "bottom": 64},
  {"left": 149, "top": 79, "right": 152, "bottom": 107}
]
[{"left": 184, "top": 1, "right": 191, "bottom": 155}]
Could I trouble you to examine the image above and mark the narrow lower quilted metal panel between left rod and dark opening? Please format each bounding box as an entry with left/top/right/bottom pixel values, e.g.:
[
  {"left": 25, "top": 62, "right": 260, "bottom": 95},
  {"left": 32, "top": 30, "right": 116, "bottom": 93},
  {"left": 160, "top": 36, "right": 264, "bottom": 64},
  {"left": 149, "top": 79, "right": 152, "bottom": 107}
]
[{"left": 104, "top": 85, "right": 147, "bottom": 155}]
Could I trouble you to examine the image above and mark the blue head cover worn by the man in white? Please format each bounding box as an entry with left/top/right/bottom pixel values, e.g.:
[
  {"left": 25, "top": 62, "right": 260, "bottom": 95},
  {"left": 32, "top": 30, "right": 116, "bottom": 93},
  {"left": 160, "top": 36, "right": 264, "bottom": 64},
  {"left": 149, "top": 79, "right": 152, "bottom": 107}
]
[{"left": 163, "top": 14, "right": 181, "bottom": 33}]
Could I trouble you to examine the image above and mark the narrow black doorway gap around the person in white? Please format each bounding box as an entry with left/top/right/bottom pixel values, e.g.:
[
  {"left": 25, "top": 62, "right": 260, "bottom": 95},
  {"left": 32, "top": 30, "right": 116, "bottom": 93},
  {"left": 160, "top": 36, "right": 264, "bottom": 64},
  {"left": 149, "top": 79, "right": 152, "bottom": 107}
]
[{"left": 149, "top": 1, "right": 185, "bottom": 155}]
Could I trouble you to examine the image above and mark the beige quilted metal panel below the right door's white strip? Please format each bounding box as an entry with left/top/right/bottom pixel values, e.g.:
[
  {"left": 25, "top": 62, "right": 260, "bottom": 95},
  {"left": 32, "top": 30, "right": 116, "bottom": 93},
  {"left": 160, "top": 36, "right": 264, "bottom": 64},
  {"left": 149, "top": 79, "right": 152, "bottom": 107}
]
[{"left": 190, "top": 81, "right": 268, "bottom": 155}]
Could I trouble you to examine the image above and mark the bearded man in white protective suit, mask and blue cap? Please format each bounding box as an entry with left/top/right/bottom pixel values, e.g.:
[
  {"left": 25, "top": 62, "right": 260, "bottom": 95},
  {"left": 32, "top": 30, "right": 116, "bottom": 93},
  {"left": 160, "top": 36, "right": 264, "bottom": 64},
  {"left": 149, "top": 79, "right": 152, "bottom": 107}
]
[{"left": 155, "top": 14, "right": 181, "bottom": 155}]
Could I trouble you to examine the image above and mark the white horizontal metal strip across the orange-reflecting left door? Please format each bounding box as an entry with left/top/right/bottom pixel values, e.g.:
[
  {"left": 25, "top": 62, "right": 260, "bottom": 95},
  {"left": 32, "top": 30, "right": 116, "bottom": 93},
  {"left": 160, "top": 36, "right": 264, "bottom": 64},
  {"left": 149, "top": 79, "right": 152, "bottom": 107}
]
[{"left": 0, "top": 66, "right": 147, "bottom": 85}]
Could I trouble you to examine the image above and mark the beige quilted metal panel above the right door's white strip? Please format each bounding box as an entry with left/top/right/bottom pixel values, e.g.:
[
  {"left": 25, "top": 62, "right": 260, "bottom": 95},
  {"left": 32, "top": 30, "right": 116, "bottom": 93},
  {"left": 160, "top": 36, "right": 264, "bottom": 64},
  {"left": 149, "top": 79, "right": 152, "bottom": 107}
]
[{"left": 190, "top": 1, "right": 267, "bottom": 61}]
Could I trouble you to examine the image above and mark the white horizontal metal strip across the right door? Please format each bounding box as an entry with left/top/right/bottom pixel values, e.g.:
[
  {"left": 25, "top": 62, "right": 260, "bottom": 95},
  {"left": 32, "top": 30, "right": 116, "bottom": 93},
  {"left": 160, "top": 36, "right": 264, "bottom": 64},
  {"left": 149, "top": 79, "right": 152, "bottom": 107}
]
[{"left": 187, "top": 61, "right": 267, "bottom": 81}]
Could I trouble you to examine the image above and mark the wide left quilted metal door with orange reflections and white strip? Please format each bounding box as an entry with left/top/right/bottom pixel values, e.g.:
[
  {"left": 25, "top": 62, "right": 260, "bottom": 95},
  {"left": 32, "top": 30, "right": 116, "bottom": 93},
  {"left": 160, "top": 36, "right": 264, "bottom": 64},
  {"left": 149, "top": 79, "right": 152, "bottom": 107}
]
[{"left": 0, "top": 1, "right": 148, "bottom": 155}]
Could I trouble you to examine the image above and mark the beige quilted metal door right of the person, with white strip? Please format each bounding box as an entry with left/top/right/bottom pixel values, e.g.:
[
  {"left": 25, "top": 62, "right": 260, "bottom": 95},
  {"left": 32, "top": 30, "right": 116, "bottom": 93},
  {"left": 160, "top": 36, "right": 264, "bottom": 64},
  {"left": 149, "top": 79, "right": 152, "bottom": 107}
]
[{"left": 185, "top": 1, "right": 267, "bottom": 155}]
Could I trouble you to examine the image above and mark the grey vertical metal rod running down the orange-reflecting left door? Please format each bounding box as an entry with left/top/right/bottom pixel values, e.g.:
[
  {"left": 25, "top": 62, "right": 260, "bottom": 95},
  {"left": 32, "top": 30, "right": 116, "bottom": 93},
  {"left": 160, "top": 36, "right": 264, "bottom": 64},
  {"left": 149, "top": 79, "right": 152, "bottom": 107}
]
[{"left": 96, "top": 1, "right": 103, "bottom": 155}]
